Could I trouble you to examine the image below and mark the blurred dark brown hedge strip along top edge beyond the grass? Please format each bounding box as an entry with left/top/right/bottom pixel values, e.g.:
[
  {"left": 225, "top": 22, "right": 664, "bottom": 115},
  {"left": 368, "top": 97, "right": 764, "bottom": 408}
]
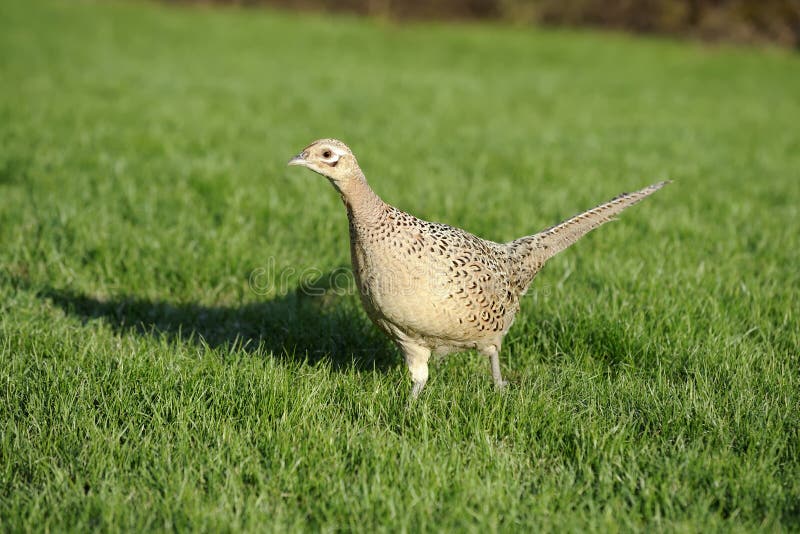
[{"left": 167, "top": 0, "right": 800, "bottom": 49}]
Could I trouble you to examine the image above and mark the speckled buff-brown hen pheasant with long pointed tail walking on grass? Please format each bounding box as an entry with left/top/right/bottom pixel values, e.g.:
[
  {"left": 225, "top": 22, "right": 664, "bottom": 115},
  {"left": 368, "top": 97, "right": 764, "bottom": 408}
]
[{"left": 289, "top": 139, "right": 668, "bottom": 398}]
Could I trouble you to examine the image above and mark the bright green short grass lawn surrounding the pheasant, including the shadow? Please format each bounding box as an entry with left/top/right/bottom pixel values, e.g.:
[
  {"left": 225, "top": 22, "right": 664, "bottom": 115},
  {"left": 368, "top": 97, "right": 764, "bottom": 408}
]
[{"left": 0, "top": 1, "right": 800, "bottom": 532}]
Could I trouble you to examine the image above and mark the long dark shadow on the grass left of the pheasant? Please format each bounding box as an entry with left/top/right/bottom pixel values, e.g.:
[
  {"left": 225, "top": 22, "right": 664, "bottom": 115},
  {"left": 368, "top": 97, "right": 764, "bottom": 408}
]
[{"left": 37, "top": 276, "right": 398, "bottom": 371}]
